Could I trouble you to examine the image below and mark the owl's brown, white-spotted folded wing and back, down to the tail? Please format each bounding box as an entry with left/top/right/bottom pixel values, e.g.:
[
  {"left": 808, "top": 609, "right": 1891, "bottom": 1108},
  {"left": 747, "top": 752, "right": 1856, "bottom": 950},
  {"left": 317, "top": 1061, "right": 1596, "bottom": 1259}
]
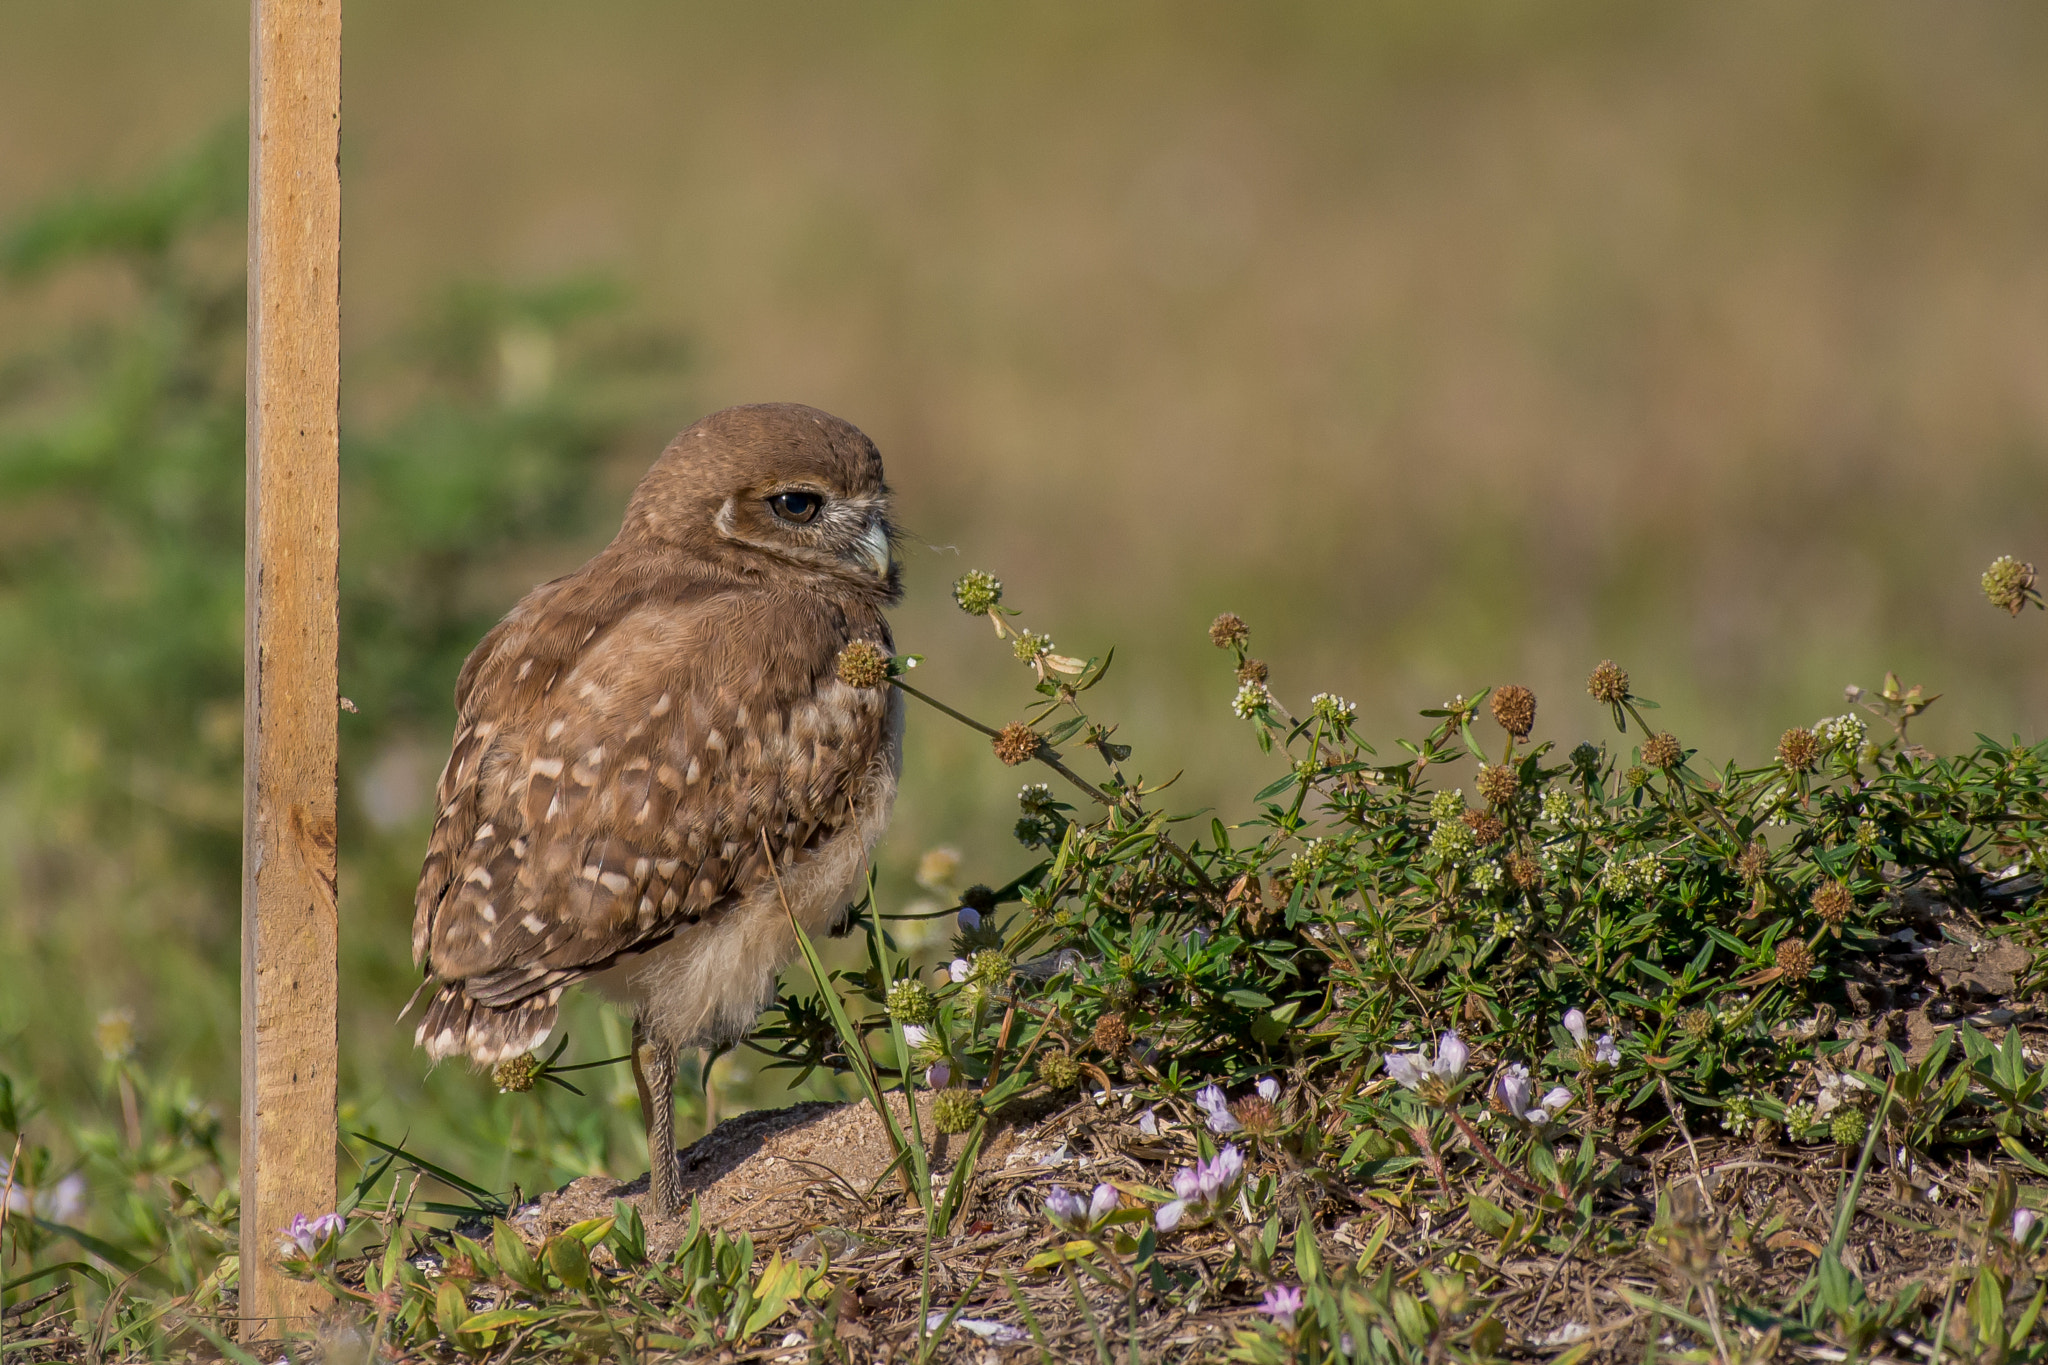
[{"left": 414, "top": 577, "right": 889, "bottom": 1062}]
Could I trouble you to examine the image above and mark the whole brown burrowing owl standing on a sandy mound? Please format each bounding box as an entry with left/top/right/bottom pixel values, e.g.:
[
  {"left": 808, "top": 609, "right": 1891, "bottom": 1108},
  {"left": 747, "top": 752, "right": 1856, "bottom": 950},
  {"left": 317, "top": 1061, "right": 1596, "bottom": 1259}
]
[{"left": 412, "top": 403, "right": 903, "bottom": 1212}]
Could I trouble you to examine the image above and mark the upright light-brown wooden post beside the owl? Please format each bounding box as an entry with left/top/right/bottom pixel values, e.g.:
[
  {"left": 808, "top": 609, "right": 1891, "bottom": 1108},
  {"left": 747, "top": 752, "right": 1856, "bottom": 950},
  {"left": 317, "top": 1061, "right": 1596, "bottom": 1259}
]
[{"left": 242, "top": 0, "right": 342, "bottom": 1340}]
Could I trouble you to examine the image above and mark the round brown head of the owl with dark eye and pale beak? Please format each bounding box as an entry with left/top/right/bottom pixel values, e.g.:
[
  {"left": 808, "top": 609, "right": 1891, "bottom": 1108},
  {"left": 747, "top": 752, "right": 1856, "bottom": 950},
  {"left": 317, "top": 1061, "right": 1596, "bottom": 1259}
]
[{"left": 621, "top": 403, "right": 899, "bottom": 598}]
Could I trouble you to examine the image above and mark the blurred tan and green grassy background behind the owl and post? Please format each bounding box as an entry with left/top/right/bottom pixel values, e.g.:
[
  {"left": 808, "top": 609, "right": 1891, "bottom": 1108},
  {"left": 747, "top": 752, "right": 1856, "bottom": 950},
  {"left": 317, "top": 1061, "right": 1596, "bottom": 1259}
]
[{"left": 0, "top": 0, "right": 2048, "bottom": 1189}]
